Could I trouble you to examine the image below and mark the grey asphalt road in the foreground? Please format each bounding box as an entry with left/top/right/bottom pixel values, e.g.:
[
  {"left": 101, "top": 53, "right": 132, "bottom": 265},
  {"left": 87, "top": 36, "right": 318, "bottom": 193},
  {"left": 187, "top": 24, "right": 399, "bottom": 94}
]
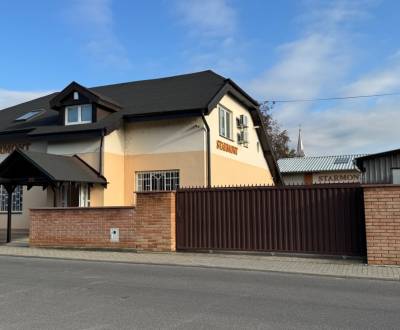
[{"left": 0, "top": 257, "right": 400, "bottom": 330}]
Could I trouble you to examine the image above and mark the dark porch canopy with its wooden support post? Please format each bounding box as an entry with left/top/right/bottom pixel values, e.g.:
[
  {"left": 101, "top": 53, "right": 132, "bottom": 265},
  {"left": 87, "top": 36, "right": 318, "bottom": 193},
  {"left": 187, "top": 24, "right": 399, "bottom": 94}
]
[{"left": 0, "top": 149, "right": 107, "bottom": 242}]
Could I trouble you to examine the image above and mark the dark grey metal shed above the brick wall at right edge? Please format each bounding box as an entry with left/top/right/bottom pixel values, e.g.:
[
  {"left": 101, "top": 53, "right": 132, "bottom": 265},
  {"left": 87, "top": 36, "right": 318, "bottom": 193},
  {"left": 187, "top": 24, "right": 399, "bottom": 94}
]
[{"left": 356, "top": 149, "right": 400, "bottom": 184}]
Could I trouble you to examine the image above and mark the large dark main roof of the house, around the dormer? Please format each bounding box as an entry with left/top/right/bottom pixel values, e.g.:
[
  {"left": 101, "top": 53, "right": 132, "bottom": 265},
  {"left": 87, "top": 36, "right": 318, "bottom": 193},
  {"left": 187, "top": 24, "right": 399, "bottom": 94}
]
[{"left": 0, "top": 70, "right": 228, "bottom": 138}]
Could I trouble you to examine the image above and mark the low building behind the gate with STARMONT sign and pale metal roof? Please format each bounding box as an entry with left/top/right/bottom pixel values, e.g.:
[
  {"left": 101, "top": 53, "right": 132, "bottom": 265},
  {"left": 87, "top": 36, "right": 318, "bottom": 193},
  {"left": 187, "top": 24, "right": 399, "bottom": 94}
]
[{"left": 278, "top": 155, "right": 362, "bottom": 185}]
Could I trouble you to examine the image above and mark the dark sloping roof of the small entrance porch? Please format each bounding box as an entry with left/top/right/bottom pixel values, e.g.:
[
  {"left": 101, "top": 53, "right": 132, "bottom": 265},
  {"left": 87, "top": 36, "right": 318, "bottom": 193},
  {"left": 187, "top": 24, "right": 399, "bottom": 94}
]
[{"left": 0, "top": 149, "right": 107, "bottom": 184}]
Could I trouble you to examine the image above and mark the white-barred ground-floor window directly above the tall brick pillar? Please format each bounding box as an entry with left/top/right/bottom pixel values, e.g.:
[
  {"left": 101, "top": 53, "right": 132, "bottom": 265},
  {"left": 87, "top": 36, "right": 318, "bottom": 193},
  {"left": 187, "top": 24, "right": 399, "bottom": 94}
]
[{"left": 136, "top": 170, "right": 179, "bottom": 191}]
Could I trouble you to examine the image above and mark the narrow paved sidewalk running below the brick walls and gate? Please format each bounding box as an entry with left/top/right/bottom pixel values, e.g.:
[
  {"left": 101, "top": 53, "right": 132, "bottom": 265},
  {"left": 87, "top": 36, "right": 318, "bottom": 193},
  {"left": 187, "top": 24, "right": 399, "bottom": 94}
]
[{"left": 0, "top": 245, "right": 400, "bottom": 281}]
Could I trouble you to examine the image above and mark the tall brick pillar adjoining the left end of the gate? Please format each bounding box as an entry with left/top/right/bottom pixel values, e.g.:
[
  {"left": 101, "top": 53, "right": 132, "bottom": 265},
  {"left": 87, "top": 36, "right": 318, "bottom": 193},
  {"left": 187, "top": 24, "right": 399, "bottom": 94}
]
[{"left": 135, "top": 192, "right": 176, "bottom": 252}]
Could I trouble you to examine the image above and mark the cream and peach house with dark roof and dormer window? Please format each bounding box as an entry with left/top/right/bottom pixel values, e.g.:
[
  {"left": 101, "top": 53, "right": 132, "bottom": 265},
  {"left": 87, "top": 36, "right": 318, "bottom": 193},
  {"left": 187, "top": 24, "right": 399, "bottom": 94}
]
[{"left": 0, "top": 71, "right": 280, "bottom": 228}]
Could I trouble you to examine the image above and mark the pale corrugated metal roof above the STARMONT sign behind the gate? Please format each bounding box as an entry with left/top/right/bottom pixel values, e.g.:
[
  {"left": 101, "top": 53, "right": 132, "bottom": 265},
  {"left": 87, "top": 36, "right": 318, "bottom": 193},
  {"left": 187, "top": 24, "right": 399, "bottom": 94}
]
[{"left": 278, "top": 154, "right": 365, "bottom": 173}]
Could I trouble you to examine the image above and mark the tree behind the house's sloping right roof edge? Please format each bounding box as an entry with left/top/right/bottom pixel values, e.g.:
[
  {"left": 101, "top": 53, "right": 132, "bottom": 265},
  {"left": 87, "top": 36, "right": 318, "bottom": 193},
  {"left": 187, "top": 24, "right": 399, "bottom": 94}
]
[{"left": 260, "top": 102, "right": 296, "bottom": 159}]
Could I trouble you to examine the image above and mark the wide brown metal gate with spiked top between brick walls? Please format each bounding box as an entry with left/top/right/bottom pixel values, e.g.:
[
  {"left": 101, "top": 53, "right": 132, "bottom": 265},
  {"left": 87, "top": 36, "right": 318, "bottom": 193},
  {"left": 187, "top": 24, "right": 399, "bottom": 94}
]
[{"left": 176, "top": 184, "right": 366, "bottom": 256}]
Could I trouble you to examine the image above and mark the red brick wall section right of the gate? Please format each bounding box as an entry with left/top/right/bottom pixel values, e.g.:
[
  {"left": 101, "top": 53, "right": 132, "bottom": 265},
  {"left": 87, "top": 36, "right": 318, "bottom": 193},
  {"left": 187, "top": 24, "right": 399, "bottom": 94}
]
[{"left": 364, "top": 186, "right": 400, "bottom": 265}]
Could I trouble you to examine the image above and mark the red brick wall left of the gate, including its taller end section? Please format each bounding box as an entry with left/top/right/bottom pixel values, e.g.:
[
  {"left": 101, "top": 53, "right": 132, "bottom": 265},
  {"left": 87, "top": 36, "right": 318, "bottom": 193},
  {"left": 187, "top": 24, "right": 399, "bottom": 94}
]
[{"left": 29, "top": 192, "right": 175, "bottom": 251}]
